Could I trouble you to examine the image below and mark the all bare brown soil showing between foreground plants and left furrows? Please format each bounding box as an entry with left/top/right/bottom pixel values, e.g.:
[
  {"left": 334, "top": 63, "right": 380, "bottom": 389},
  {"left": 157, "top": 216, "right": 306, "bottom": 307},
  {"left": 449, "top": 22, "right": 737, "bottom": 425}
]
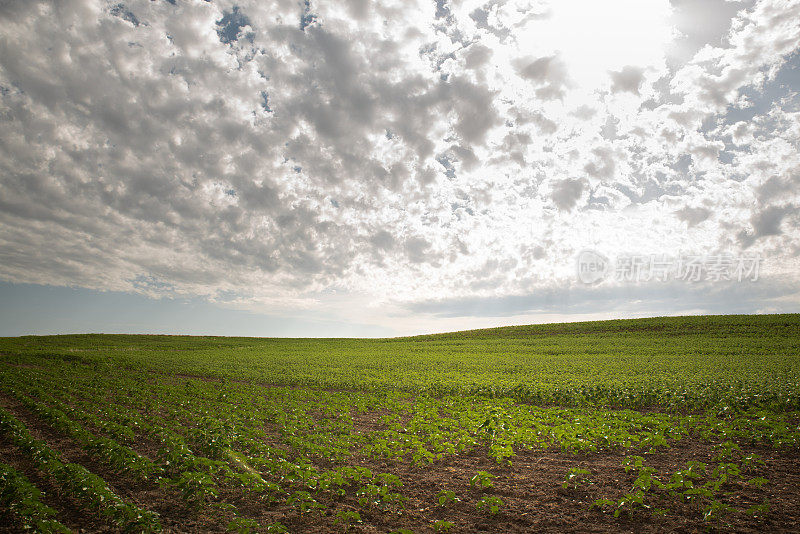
[{"left": 0, "top": 397, "right": 800, "bottom": 534}]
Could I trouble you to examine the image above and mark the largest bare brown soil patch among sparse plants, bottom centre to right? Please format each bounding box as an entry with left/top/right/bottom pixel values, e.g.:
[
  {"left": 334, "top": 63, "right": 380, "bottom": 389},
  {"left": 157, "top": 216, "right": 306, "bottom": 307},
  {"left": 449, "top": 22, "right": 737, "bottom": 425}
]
[{"left": 266, "top": 440, "right": 800, "bottom": 533}]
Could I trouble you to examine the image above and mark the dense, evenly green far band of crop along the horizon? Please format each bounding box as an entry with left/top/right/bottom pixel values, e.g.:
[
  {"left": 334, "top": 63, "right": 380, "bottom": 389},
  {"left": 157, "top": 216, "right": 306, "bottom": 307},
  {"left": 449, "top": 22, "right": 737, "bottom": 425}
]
[{"left": 0, "top": 314, "right": 800, "bottom": 409}]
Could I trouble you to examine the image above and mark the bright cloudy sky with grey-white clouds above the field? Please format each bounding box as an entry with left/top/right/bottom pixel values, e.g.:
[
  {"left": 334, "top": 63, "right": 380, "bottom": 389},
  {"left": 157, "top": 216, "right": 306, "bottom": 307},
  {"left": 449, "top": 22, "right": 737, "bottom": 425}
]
[{"left": 0, "top": 0, "right": 800, "bottom": 336}]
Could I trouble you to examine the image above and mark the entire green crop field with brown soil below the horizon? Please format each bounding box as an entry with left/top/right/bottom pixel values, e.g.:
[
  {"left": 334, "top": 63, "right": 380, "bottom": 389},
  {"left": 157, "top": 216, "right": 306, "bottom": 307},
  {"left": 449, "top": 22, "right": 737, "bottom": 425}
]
[{"left": 0, "top": 315, "right": 800, "bottom": 533}]
